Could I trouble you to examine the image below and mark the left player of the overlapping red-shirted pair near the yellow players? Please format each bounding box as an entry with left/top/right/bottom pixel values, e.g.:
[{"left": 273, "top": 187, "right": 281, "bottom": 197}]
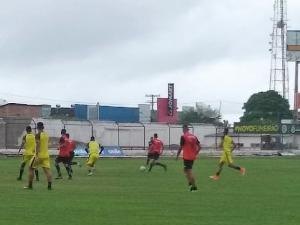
[{"left": 55, "top": 129, "right": 72, "bottom": 180}]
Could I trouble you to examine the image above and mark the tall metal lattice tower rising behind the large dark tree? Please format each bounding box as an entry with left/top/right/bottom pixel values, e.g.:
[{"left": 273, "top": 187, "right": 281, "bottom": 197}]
[{"left": 269, "top": 0, "right": 289, "bottom": 99}]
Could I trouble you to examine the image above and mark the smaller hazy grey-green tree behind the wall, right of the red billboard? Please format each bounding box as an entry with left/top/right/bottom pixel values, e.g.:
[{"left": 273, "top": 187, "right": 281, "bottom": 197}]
[{"left": 180, "top": 103, "right": 221, "bottom": 123}]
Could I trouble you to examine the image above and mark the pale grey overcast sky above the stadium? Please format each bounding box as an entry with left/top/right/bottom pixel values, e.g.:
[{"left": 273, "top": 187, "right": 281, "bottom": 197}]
[{"left": 0, "top": 0, "right": 300, "bottom": 122}]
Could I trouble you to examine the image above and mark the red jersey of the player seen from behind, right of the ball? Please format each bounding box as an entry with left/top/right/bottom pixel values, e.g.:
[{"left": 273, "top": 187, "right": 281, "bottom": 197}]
[{"left": 180, "top": 132, "right": 201, "bottom": 160}]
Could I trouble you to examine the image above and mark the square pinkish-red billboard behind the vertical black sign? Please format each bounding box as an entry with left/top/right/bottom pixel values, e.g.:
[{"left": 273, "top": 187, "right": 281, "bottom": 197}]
[{"left": 157, "top": 98, "right": 178, "bottom": 123}]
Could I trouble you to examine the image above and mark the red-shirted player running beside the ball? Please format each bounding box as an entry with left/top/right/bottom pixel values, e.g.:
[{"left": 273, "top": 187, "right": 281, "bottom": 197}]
[{"left": 147, "top": 133, "right": 167, "bottom": 172}]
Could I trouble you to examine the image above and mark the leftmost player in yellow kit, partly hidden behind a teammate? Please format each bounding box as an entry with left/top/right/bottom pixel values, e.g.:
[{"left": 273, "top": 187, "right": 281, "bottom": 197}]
[{"left": 17, "top": 126, "right": 39, "bottom": 181}]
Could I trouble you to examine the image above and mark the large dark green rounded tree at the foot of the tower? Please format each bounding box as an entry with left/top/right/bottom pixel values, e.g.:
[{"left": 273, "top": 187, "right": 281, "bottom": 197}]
[{"left": 240, "top": 90, "right": 293, "bottom": 123}]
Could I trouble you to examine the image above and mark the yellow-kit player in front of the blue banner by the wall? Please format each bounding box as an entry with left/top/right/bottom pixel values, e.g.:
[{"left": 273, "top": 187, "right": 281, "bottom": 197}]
[{"left": 85, "top": 136, "right": 103, "bottom": 176}]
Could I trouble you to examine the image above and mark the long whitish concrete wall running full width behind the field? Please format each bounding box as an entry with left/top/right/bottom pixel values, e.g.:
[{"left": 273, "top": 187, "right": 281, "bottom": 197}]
[{"left": 0, "top": 118, "right": 300, "bottom": 151}]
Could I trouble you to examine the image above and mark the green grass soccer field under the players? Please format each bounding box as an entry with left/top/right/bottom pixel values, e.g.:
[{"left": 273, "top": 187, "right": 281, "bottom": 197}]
[{"left": 0, "top": 157, "right": 300, "bottom": 225}]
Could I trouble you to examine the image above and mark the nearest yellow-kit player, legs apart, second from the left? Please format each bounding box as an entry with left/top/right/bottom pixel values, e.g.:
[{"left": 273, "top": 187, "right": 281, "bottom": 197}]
[{"left": 24, "top": 122, "right": 52, "bottom": 190}]
